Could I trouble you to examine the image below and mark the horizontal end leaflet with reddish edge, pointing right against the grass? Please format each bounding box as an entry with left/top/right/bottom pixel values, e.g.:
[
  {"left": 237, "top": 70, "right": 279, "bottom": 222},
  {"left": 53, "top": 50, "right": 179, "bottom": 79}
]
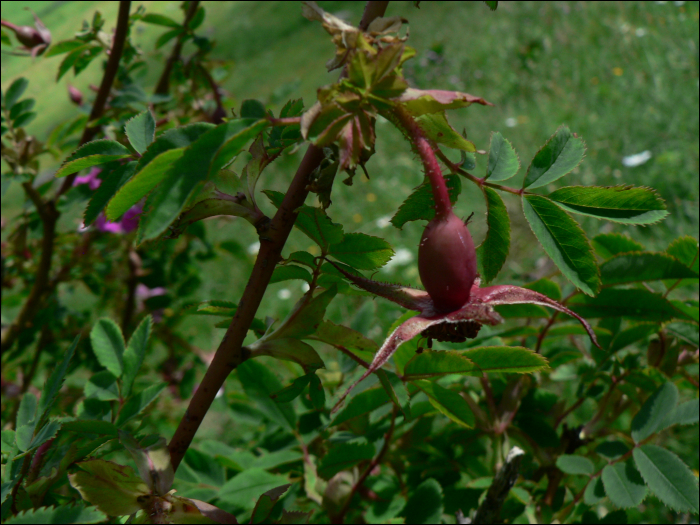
[{"left": 549, "top": 186, "right": 668, "bottom": 224}]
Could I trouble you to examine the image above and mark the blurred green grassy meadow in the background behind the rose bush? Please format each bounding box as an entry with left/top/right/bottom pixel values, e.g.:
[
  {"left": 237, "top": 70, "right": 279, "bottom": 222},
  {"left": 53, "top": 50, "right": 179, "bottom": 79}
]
[{"left": 2, "top": 2, "right": 699, "bottom": 348}]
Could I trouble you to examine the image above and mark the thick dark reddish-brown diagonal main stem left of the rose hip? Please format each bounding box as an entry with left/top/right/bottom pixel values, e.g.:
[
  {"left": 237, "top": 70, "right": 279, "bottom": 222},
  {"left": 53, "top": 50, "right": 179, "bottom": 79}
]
[{"left": 168, "top": 1, "right": 388, "bottom": 470}]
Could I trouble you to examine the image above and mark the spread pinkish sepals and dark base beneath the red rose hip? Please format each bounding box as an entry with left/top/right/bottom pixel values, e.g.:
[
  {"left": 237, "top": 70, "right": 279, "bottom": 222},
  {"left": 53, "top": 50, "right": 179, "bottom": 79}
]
[{"left": 328, "top": 261, "right": 599, "bottom": 412}]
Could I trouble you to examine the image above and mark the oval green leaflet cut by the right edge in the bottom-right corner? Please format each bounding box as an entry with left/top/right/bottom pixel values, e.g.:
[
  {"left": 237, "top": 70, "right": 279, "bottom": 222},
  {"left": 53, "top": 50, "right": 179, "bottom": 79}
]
[{"left": 632, "top": 445, "right": 700, "bottom": 514}]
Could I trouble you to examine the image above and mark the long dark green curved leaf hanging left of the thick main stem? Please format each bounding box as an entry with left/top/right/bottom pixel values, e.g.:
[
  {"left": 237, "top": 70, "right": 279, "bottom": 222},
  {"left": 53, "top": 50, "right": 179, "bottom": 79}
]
[{"left": 140, "top": 119, "right": 268, "bottom": 242}]
